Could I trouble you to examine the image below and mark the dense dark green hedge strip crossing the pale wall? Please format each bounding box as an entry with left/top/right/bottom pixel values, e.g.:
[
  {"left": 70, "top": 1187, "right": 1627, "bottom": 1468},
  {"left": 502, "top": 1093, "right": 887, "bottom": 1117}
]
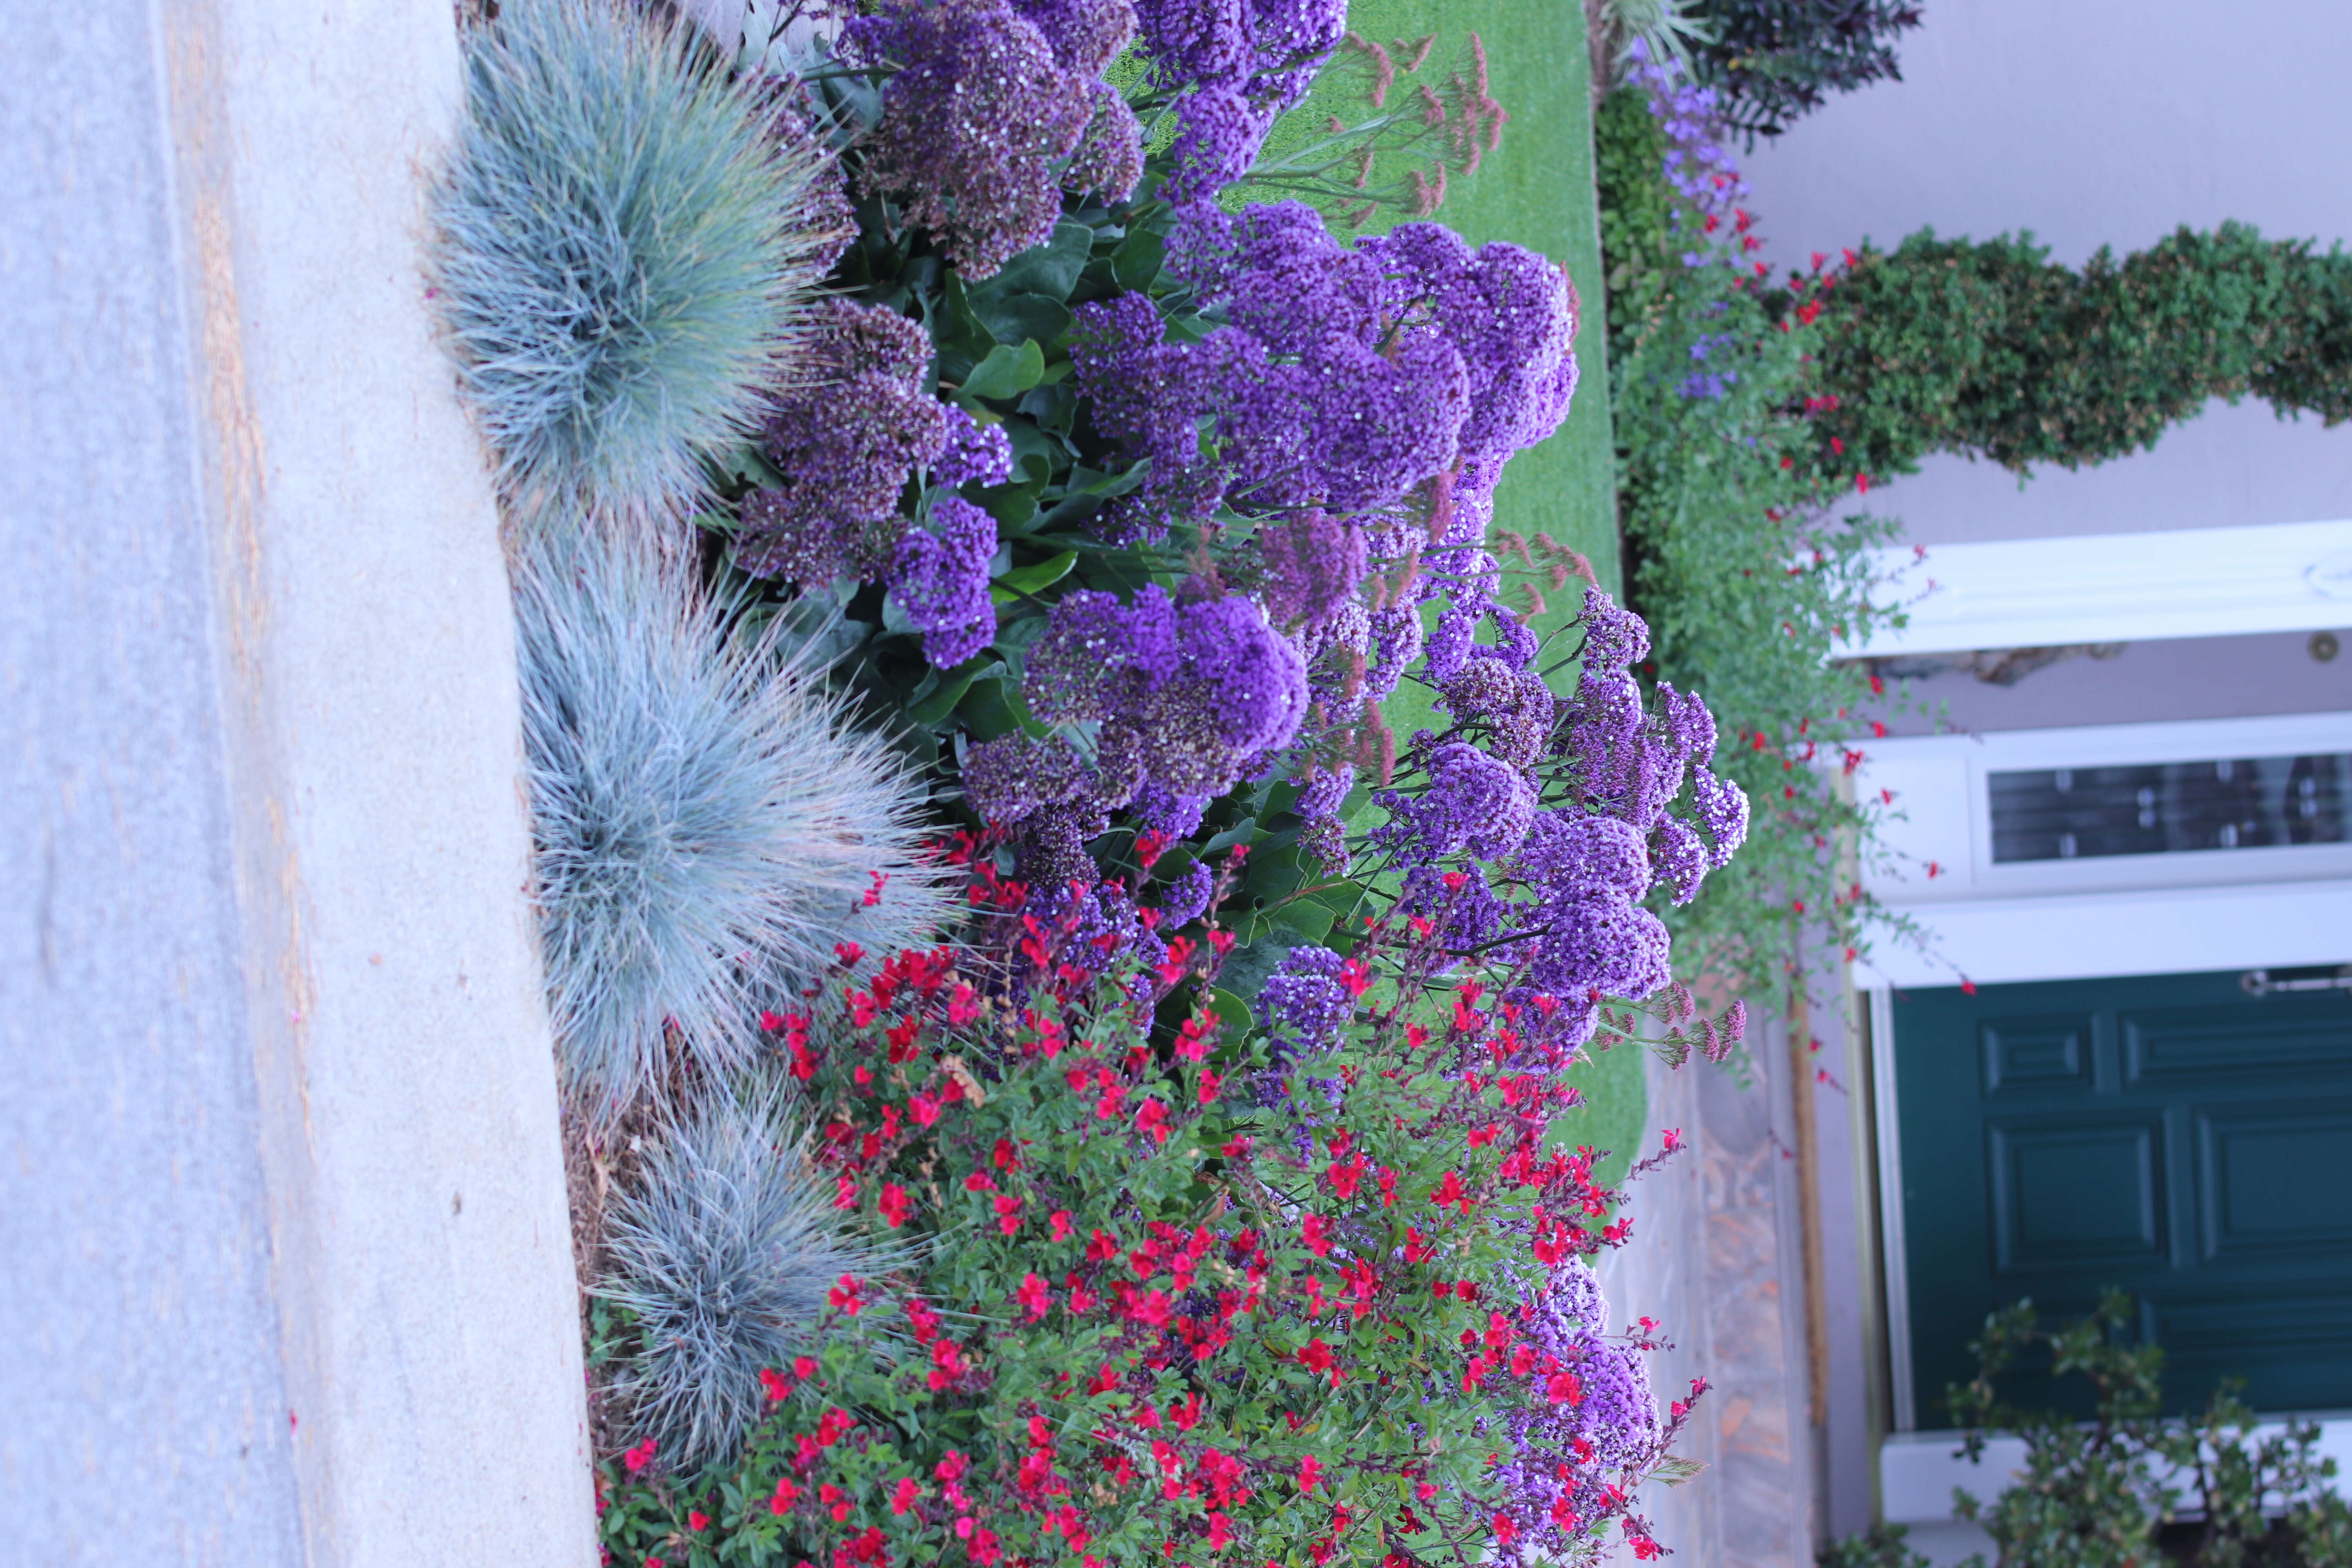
[{"left": 1816, "top": 223, "right": 2352, "bottom": 475}]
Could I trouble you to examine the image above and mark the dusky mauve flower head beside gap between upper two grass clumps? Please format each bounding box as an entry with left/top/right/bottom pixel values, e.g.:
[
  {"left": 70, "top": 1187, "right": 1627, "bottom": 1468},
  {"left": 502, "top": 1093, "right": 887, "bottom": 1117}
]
[{"left": 736, "top": 296, "right": 950, "bottom": 583}]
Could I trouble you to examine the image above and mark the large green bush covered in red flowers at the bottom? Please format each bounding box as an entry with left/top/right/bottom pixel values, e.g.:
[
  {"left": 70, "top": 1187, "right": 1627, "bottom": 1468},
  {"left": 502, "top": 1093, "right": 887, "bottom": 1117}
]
[{"left": 586, "top": 844, "right": 1696, "bottom": 1566}]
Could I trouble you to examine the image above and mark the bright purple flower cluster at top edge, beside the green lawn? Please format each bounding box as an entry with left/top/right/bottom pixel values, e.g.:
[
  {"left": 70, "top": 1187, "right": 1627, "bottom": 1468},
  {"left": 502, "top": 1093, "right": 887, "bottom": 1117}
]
[{"left": 1138, "top": 0, "right": 1348, "bottom": 202}]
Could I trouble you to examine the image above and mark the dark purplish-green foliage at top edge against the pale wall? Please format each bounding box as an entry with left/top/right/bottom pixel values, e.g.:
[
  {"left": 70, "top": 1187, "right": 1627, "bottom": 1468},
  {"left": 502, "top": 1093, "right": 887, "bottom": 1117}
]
[{"left": 1693, "top": 0, "right": 1919, "bottom": 136}]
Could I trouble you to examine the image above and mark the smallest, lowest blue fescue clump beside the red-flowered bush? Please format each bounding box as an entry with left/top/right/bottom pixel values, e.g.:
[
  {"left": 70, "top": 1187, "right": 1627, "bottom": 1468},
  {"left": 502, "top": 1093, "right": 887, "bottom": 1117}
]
[{"left": 597, "top": 1086, "right": 891, "bottom": 1472}]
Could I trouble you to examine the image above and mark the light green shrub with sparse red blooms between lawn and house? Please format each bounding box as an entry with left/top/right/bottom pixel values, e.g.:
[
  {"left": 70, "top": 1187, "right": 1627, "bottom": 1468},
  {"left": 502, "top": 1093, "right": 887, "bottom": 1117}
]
[{"left": 1599, "top": 76, "right": 1905, "bottom": 990}]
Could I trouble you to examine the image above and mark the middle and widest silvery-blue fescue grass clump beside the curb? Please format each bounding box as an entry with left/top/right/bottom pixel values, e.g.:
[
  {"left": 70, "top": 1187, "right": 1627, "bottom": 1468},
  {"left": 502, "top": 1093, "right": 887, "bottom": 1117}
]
[{"left": 515, "top": 526, "right": 948, "bottom": 1119}]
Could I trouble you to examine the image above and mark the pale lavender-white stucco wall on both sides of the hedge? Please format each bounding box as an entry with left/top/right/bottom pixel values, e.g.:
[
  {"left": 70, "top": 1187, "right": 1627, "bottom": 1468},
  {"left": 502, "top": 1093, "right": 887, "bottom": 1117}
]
[{"left": 1745, "top": 0, "right": 2352, "bottom": 545}]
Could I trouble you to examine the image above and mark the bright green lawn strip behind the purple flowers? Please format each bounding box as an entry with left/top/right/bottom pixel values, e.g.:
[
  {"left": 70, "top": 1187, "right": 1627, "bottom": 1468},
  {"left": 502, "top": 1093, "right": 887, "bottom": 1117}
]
[{"left": 1270, "top": 0, "right": 1649, "bottom": 1180}]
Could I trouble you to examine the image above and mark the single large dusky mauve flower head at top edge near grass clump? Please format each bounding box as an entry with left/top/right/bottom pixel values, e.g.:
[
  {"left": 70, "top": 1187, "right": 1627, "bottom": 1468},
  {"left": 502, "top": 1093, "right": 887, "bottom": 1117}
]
[{"left": 842, "top": 0, "right": 1096, "bottom": 280}]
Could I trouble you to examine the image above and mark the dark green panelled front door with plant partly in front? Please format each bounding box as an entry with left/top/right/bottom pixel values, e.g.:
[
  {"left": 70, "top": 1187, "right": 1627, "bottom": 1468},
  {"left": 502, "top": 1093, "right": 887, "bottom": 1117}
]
[{"left": 1893, "top": 971, "right": 2352, "bottom": 1427}]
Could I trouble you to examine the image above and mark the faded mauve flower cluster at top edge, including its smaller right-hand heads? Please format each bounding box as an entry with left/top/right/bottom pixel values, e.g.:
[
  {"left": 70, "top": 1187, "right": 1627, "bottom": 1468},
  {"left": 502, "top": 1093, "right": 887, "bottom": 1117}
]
[{"left": 842, "top": 0, "right": 1143, "bottom": 280}]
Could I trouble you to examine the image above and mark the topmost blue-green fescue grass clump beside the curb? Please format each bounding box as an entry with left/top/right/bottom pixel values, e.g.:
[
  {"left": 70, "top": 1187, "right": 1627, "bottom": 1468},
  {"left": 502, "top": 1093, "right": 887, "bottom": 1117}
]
[{"left": 435, "top": 0, "right": 837, "bottom": 517}]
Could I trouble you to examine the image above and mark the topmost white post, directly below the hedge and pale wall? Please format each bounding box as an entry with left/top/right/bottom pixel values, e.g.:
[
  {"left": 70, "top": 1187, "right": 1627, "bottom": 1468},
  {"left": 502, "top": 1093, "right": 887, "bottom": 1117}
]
[{"left": 1842, "top": 522, "right": 2352, "bottom": 658}]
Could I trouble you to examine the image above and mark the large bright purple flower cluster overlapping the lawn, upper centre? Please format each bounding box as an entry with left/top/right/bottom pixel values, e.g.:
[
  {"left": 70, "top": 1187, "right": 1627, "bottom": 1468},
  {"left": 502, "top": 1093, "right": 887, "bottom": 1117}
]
[{"left": 1073, "top": 202, "right": 1576, "bottom": 592}]
